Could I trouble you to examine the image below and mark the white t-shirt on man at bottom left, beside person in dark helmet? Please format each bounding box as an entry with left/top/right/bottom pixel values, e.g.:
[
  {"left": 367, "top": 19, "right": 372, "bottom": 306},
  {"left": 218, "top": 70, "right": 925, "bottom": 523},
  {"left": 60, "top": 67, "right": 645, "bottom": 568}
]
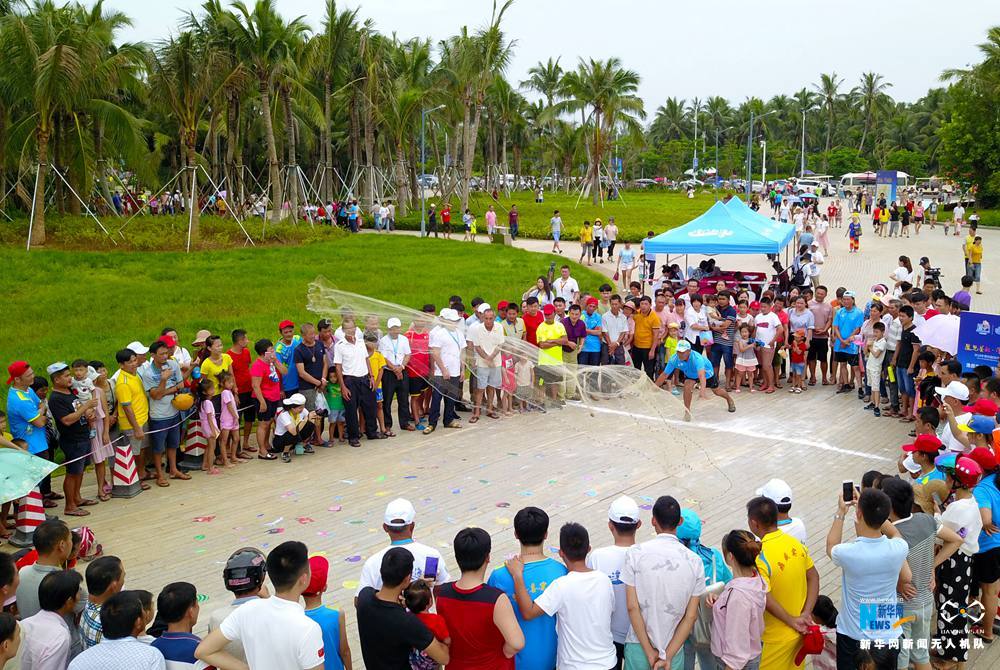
[{"left": 219, "top": 596, "right": 323, "bottom": 670}]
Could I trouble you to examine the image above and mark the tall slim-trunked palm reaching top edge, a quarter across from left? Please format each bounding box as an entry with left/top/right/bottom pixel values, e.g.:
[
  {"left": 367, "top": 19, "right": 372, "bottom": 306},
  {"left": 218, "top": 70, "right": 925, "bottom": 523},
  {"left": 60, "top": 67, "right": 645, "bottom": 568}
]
[{"left": 223, "top": 0, "right": 307, "bottom": 223}]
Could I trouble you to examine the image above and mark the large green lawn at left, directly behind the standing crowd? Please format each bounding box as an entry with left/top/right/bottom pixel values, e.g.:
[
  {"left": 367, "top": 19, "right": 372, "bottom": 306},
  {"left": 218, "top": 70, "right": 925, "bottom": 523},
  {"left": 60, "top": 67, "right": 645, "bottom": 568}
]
[{"left": 0, "top": 235, "right": 605, "bottom": 380}]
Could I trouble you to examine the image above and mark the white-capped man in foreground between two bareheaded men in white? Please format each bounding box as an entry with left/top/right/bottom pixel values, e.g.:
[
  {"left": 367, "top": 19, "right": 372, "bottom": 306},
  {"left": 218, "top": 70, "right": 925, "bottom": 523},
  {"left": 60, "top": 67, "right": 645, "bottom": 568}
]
[{"left": 587, "top": 496, "right": 642, "bottom": 664}]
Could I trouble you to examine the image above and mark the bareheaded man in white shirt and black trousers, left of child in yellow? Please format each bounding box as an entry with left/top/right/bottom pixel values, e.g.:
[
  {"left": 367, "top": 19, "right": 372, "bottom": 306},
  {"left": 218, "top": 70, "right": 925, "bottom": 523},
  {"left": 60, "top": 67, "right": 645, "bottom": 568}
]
[{"left": 333, "top": 316, "right": 382, "bottom": 447}]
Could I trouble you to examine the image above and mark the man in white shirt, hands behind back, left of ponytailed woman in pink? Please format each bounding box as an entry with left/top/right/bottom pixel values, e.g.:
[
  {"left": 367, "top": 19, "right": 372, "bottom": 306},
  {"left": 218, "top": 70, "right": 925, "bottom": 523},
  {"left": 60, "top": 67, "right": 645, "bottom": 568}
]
[{"left": 621, "top": 496, "right": 705, "bottom": 667}]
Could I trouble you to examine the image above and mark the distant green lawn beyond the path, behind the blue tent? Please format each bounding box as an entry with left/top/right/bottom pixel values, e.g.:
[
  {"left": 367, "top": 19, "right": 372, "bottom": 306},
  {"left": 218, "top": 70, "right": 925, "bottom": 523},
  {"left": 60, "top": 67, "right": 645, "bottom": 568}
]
[{"left": 399, "top": 190, "right": 723, "bottom": 242}]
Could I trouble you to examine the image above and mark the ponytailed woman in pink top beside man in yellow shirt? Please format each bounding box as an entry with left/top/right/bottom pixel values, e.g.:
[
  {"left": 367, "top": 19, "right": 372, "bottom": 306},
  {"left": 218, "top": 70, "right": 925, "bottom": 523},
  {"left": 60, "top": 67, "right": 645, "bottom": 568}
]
[{"left": 712, "top": 530, "right": 767, "bottom": 670}]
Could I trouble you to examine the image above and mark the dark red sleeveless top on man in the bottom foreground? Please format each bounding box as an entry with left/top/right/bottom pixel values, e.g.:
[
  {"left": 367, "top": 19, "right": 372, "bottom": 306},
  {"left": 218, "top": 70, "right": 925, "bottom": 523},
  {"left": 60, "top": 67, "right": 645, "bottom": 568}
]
[{"left": 435, "top": 582, "right": 514, "bottom": 670}]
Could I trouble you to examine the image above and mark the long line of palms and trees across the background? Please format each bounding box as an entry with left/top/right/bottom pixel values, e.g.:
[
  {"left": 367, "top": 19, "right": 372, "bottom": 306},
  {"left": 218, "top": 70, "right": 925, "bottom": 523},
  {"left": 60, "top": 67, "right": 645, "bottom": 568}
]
[{"left": 0, "top": 0, "right": 1000, "bottom": 244}]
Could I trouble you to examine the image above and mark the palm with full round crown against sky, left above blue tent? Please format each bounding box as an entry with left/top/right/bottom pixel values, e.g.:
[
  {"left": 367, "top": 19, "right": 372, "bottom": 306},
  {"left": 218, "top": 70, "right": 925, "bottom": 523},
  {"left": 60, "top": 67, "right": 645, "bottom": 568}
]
[{"left": 555, "top": 58, "right": 646, "bottom": 205}]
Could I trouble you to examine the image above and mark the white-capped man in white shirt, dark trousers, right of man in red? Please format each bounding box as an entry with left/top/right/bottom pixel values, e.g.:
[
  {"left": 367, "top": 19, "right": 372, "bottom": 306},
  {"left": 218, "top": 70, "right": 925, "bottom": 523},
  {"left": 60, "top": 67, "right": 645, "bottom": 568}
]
[{"left": 424, "top": 307, "right": 466, "bottom": 435}]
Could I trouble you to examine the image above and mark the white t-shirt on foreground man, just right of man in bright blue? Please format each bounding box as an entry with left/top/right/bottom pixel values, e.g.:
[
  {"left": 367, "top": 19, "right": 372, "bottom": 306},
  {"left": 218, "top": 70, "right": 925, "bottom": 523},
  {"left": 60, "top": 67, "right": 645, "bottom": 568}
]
[{"left": 535, "top": 570, "right": 616, "bottom": 670}]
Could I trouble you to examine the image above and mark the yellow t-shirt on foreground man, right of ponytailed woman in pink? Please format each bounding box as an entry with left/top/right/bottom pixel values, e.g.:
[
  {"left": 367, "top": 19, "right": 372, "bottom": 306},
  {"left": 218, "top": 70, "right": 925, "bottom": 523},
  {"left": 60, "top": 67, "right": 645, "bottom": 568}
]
[{"left": 757, "top": 530, "right": 813, "bottom": 644}]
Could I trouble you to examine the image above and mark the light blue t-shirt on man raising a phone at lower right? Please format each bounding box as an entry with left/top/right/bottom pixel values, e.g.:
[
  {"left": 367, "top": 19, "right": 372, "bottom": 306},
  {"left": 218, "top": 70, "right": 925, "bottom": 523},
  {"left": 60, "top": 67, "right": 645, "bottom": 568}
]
[{"left": 830, "top": 537, "right": 910, "bottom": 640}]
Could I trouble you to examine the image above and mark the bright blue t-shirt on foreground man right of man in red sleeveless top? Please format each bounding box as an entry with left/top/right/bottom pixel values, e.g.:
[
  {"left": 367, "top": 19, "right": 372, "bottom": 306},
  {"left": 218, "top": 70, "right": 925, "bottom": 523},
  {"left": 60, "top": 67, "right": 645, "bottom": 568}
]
[{"left": 487, "top": 558, "right": 566, "bottom": 670}]
